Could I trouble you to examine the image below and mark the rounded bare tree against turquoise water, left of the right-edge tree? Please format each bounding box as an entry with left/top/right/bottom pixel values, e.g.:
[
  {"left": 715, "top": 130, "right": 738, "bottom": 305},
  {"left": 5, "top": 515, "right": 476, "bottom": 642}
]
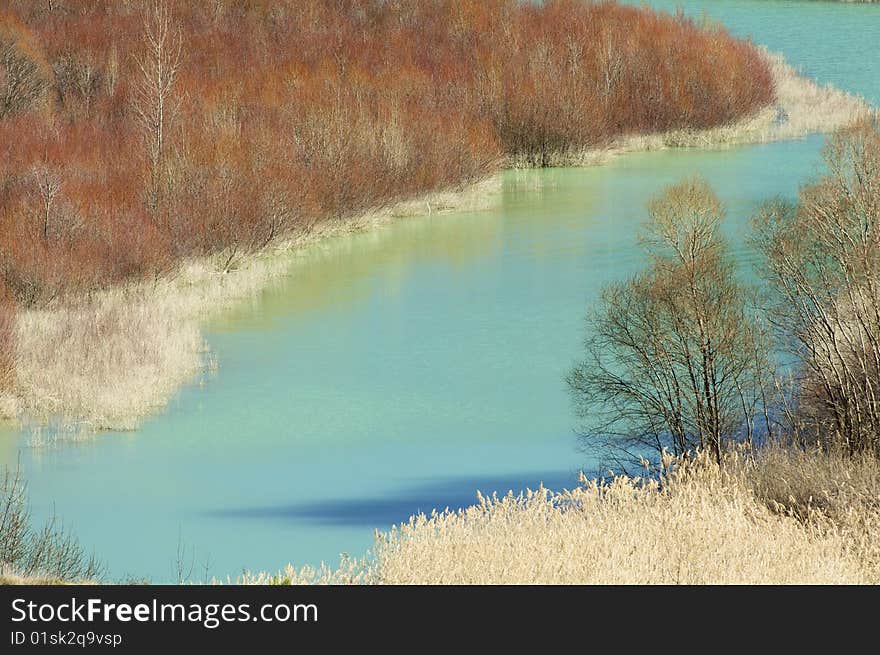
[{"left": 568, "top": 180, "right": 769, "bottom": 461}]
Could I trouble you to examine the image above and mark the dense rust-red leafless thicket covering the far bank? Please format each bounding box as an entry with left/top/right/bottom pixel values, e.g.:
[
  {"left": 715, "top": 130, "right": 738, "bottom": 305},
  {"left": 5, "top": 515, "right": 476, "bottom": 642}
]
[{"left": 0, "top": 0, "right": 774, "bottom": 394}]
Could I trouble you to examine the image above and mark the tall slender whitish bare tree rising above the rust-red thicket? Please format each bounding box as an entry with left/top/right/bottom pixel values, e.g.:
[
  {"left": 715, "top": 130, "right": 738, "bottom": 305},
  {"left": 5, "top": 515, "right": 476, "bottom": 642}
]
[{"left": 134, "top": 0, "right": 183, "bottom": 220}]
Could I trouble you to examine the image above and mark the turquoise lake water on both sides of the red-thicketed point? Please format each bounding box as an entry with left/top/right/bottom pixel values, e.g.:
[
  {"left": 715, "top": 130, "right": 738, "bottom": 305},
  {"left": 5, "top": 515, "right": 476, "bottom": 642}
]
[{"left": 0, "top": 0, "right": 880, "bottom": 582}]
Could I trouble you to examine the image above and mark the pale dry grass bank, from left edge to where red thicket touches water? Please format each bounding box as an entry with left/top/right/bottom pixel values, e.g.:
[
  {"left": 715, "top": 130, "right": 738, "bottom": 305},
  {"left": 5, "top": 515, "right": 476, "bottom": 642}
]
[{"left": 0, "top": 177, "right": 501, "bottom": 437}]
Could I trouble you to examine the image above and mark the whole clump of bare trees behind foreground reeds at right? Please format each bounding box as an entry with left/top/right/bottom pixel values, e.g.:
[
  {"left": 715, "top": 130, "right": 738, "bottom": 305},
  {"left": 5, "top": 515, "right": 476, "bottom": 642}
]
[{"left": 569, "top": 119, "right": 880, "bottom": 460}]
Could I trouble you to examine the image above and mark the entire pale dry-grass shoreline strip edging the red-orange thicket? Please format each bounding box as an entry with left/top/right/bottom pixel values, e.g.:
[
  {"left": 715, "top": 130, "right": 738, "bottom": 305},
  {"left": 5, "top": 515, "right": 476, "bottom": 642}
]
[{"left": 0, "top": 50, "right": 874, "bottom": 442}]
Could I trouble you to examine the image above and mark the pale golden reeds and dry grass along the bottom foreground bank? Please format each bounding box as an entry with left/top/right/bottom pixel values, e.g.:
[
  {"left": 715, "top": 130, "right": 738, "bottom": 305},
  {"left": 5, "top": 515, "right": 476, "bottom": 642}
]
[{"left": 239, "top": 448, "right": 880, "bottom": 584}]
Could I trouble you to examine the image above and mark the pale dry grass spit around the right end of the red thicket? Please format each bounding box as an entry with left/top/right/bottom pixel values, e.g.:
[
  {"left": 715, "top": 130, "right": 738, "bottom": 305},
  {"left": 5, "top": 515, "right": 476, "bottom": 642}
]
[{"left": 509, "top": 50, "right": 875, "bottom": 168}]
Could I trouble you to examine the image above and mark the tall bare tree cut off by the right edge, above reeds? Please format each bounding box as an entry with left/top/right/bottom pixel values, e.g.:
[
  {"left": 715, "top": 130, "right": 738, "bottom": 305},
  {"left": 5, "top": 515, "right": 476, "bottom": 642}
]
[{"left": 756, "top": 120, "right": 880, "bottom": 453}]
